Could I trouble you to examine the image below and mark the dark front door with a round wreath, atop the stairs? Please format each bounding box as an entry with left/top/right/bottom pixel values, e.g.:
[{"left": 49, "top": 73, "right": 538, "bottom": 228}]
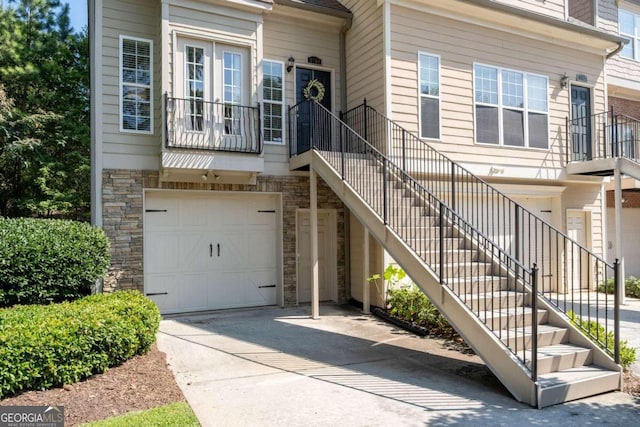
[{"left": 295, "top": 67, "right": 331, "bottom": 153}]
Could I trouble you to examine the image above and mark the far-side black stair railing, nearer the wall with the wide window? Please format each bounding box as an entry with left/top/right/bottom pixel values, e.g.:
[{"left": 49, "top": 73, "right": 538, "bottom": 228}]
[{"left": 341, "top": 101, "right": 619, "bottom": 363}]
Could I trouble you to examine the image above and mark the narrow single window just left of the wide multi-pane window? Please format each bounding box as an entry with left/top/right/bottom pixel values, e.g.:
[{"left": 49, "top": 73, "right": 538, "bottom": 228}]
[{"left": 418, "top": 53, "right": 440, "bottom": 139}]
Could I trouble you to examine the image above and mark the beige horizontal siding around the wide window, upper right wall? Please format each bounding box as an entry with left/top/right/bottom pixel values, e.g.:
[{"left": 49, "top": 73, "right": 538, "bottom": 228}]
[{"left": 391, "top": 6, "right": 604, "bottom": 172}]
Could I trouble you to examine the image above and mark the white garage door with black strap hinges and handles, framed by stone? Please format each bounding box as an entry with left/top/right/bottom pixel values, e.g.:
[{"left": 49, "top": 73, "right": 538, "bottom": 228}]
[{"left": 144, "top": 192, "right": 279, "bottom": 314}]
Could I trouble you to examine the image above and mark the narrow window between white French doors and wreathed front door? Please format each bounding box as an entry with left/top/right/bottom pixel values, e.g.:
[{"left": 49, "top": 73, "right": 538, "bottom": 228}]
[{"left": 262, "top": 60, "right": 284, "bottom": 144}]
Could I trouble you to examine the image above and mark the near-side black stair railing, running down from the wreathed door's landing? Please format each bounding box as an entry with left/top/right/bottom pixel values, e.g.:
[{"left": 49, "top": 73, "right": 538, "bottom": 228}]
[{"left": 289, "top": 101, "right": 552, "bottom": 381}]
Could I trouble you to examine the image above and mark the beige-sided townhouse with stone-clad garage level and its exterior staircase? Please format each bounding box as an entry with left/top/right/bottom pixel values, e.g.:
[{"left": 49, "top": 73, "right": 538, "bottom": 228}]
[{"left": 90, "top": 0, "right": 623, "bottom": 407}]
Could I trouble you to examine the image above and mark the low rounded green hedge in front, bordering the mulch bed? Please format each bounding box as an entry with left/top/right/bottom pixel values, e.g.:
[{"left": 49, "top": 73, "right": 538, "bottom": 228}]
[{"left": 0, "top": 291, "right": 160, "bottom": 398}]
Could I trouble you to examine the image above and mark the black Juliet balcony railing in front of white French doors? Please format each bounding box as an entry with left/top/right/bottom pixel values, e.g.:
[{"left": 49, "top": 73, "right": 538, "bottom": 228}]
[{"left": 164, "top": 95, "right": 262, "bottom": 154}]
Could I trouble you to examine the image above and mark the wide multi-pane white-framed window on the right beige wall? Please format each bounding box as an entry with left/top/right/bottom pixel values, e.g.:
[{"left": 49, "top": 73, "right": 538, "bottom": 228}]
[{"left": 474, "top": 64, "right": 549, "bottom": 149}]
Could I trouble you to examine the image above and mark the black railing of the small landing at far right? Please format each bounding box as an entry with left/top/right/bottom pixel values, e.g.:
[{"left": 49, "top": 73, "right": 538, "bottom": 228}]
[{"left": 566, "top": 107, "right": 640, "bottom": 163}]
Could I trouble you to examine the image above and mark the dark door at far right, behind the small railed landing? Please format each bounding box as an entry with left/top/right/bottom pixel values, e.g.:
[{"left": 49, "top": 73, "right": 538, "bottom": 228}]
[{"left": 571, "top": 85, "right": 592, "bottom": 161}]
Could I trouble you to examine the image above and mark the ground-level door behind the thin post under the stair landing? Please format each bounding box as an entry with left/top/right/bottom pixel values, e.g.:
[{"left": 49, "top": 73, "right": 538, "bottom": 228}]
[{"left": 297, "top": 210, "right": 338, "bottom": 302}]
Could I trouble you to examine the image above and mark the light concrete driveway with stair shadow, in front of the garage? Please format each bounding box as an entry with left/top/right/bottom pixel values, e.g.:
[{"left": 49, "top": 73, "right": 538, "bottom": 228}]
[{"left": 158, "top": 305, "right": 640, "bottom": 426}]
